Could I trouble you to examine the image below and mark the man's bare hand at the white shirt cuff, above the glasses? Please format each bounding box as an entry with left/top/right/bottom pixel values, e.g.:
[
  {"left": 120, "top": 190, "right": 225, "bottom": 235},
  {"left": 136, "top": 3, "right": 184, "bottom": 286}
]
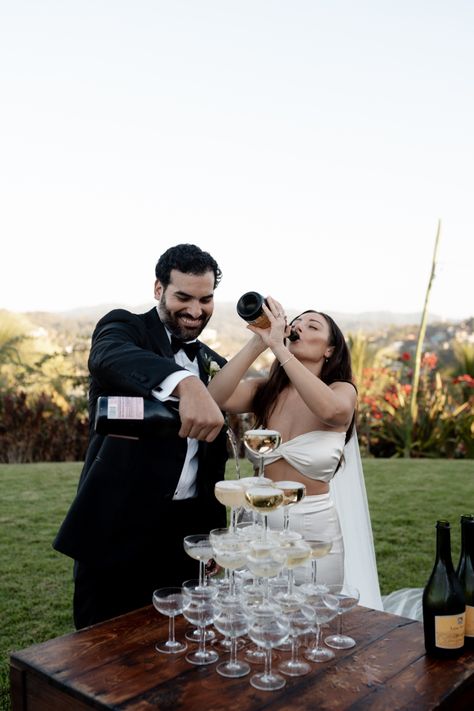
[{"left": 173, "top": 376, "right": 224, "bottom": 442}]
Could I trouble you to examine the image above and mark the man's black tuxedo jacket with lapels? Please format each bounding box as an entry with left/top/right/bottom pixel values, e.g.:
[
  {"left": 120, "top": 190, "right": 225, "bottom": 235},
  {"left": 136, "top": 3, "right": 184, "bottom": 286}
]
[{"left": 53, "top": 308, "right": 227, "bottom": 567}]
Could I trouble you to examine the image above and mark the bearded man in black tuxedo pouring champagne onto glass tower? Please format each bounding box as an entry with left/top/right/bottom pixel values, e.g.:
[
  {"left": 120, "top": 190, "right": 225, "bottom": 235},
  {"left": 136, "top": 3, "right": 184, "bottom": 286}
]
[{"left": 53, "top": 244, "right": 227, "bottom": 628}]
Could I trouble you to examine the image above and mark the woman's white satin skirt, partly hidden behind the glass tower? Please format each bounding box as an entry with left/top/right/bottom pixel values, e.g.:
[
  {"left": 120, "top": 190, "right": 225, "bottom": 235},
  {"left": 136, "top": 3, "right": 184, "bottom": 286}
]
[{"left": 268, "top": 492, "right": 344, "bottom": 584}]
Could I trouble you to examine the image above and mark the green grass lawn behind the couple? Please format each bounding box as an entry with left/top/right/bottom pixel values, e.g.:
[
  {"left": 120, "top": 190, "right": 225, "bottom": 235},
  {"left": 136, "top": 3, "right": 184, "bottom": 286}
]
[{"left": 0, "top": 459, "right": 474, "bottom": 710}]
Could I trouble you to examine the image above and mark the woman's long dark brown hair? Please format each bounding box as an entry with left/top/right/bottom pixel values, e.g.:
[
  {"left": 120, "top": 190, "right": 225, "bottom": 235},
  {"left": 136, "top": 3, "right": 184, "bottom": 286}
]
[{"left": 252, "top": 309, "right": 355, "bottom": 442}]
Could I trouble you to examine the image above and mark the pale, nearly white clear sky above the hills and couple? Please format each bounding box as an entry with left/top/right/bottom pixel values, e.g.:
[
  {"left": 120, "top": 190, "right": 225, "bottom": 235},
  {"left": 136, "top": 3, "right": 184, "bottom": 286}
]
[{"left": 0, "top": 0, "right": 474, "bottom": 319}]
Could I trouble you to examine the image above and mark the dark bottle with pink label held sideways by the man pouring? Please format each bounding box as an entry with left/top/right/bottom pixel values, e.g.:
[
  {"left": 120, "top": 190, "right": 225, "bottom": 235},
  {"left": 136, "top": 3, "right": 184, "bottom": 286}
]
[{"left": 94, "top": 395, "right": 181, "bottom": 439}]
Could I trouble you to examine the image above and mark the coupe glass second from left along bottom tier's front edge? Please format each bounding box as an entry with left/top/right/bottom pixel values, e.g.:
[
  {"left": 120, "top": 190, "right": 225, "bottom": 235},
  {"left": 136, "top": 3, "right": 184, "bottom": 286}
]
[{"left": 182, "top": 580, "right": 219, "bottom": 664}]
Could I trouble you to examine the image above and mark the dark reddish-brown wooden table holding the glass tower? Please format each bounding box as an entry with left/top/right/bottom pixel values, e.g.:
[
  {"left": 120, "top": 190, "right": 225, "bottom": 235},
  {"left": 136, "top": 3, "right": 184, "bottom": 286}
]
[{"left": 11, "top": 606, "right": 474, "bottom": 711}]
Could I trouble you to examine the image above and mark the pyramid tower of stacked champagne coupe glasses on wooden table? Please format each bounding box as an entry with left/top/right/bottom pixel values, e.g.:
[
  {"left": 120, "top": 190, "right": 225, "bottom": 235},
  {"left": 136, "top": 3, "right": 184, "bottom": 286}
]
[{"left": 153, "top": 430, "right": 359, "bottom": 691}]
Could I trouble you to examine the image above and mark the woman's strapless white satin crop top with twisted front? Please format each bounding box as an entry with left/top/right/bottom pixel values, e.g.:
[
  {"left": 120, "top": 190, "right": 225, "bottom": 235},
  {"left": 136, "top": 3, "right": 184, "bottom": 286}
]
[{"left": 247, "top": 430, "right": 346, "bottom": 482}]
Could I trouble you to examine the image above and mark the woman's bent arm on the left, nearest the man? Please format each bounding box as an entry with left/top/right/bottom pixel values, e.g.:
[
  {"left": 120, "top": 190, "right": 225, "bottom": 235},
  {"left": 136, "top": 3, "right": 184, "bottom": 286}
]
[{"left": 207, "top": 334, "right": 266, "bottom": 414}]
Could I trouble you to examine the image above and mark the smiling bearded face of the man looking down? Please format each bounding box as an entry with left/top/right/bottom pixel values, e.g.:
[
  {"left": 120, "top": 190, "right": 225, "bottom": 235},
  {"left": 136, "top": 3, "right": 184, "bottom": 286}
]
[{"left": 155, "top": 269, "right": 214, "bottom": 341}]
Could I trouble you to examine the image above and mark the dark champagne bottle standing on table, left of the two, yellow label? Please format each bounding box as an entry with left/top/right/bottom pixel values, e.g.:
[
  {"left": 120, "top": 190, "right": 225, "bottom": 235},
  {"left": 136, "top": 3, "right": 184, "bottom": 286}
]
[{"left": 423, "top": 521, "right": 466, "bottom": 658}]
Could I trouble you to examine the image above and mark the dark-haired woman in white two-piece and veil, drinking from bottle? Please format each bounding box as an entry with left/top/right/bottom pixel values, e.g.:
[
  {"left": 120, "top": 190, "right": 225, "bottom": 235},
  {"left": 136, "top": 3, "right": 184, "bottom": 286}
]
[{"left": 208, "top": 297, "right": 383, "bottom": 610}]
